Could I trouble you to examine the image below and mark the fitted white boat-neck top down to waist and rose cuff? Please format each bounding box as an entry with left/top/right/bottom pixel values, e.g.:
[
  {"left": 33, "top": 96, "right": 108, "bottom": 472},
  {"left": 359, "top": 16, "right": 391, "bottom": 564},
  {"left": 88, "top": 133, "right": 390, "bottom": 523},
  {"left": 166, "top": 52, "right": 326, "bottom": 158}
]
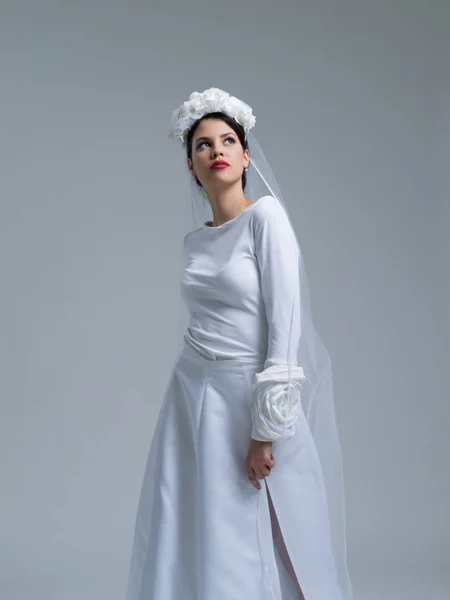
[{"left": 180, "top": 196, "right": 301, "bottom": 367}]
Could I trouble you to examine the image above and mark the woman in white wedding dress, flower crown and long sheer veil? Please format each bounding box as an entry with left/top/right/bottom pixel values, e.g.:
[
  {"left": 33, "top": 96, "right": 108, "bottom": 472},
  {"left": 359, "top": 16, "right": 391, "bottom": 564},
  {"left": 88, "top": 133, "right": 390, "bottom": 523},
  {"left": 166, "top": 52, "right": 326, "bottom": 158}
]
[{"left": 123, "top": 88, "right": 351, "bottom": 600}]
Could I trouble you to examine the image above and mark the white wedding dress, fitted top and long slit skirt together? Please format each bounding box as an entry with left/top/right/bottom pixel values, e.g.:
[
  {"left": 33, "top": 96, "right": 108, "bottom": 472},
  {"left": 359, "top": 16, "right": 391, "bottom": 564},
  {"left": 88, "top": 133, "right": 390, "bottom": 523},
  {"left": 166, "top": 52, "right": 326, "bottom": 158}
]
[{"left": 126, "top": 196, "right": 343, "bottom": 600}]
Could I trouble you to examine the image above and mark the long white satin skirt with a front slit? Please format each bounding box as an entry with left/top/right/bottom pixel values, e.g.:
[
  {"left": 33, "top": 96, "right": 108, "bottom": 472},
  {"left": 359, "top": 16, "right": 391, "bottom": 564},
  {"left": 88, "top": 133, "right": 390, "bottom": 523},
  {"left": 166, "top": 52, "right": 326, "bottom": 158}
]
[{"left": 126, "top": 344, "right": 342, "bottom": 600}]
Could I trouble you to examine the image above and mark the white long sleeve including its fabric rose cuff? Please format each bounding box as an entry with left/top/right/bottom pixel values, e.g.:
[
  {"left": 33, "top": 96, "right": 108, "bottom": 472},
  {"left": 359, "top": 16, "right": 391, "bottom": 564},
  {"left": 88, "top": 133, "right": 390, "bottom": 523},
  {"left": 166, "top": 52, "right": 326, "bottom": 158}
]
[{"left": 247, "top": 198, "right": 305, "bottom": 442}]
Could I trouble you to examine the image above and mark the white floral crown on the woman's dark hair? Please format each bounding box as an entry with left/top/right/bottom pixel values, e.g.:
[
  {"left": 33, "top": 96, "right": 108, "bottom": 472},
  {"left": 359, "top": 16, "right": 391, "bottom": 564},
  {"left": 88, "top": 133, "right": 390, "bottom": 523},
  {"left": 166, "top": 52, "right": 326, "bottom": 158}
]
[{"left": 168, "top": 88, "right": 256, "bottom": 146}]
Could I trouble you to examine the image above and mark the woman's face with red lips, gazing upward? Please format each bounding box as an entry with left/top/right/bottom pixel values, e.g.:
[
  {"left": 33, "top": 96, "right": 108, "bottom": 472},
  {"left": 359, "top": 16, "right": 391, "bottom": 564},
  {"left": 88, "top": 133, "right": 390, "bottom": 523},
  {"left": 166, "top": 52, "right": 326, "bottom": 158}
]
[{"left": 188, "top": 119, "right": 250, "bottom": 190}]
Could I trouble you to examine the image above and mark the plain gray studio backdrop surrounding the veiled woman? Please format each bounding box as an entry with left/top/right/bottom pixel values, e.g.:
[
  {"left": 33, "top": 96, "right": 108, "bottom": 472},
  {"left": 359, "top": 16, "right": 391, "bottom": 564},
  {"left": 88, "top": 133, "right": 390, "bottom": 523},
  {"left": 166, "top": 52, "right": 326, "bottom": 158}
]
[{"left": 0, "top": 0, "right": 450, "bottom": 600}]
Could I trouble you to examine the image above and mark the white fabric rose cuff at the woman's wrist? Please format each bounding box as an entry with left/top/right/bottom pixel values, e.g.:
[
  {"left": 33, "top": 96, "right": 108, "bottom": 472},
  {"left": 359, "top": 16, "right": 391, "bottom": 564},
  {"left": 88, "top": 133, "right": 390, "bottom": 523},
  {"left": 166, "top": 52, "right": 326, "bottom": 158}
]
[{"left": 247, "top": 365, "right": 305, "bottom": 442}]
